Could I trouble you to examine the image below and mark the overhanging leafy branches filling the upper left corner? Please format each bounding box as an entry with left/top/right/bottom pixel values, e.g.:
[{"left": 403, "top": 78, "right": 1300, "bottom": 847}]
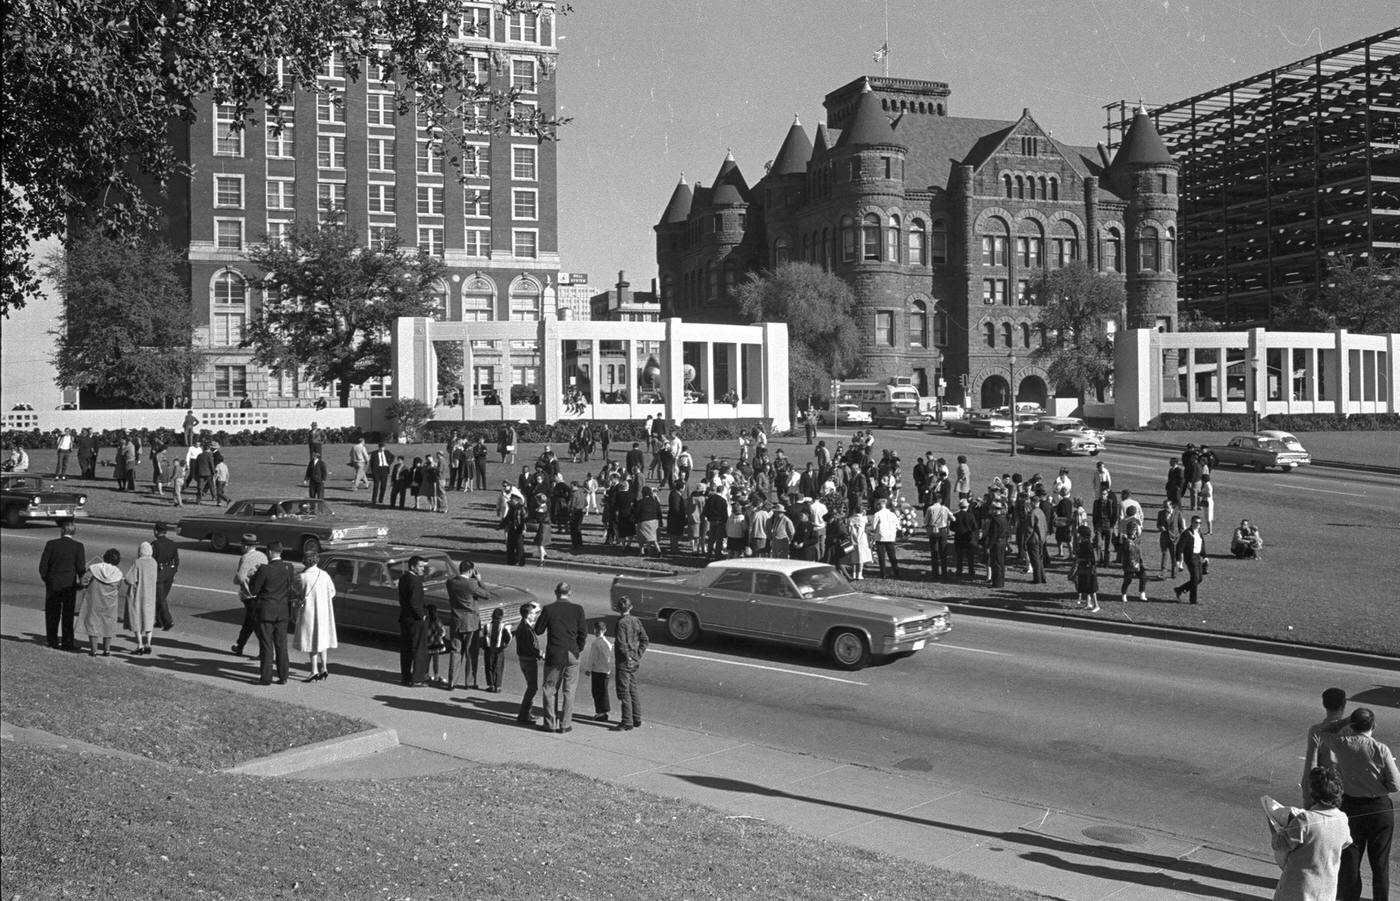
[{"left": 0, "top": 0, "right": 568, "bottom": 316}]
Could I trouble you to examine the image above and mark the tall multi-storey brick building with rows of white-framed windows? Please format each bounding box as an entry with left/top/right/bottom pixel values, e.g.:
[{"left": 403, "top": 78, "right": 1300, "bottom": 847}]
[{"left": 165, "top": 3, "right": 559, "bottom": 407}]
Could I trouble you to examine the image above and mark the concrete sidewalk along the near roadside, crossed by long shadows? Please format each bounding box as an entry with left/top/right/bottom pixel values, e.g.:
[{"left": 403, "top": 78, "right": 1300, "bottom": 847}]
[{"left": 0, "top": 604, "right": 1278, "bottom": 901}]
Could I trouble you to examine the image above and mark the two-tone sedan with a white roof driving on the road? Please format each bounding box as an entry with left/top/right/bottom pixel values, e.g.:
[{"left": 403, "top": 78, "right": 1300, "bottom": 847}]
[{"left": 612, "top": 558, "right": 952, "bottom": 670}]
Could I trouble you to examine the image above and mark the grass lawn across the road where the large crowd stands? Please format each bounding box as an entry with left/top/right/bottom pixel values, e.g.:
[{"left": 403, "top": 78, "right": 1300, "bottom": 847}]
[{"left": 54, "top": 430, "right": 1400, "bottom": 655}]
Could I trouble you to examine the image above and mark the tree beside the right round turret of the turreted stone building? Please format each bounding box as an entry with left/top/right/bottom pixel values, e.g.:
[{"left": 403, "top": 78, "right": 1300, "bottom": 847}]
[{"left": 1030, "top": 263, "right": 1126, "bottom": 400}]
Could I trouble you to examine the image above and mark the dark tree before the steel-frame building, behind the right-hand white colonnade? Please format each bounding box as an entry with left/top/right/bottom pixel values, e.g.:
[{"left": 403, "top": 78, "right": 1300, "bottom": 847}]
[{"left": 1274, "top": 256, "right": 1400, "bottom": 334}]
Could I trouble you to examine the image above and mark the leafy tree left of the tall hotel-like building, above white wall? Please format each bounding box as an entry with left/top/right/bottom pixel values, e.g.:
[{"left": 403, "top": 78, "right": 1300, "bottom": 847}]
[{"left": 46, "top": 232, "right": 199, "bottom": 407}]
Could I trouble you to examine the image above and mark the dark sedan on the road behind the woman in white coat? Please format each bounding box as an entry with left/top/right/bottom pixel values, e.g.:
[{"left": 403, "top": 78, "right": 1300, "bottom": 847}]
[{"left": 179, "top": 498, "right": 389, "bottom": 554}]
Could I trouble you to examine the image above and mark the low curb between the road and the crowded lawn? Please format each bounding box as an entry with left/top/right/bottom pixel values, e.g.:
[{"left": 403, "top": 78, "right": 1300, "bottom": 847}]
[{"left": 68, "top": 514, "right": 1400, "bottom": 669}]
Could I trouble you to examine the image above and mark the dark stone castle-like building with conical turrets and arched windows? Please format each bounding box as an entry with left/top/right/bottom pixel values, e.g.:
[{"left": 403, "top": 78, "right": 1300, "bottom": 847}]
[{"left": 655, "top": 77, "right": 1177, "bottom": 406}]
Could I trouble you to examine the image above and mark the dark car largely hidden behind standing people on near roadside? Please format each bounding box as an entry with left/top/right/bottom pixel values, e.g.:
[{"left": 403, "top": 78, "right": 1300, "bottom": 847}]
[{"left": 319, "top": 544, "right": 536, "bottom": 637}]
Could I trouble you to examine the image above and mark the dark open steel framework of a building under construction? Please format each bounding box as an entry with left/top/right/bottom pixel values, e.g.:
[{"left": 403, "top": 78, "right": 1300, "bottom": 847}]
[{"left": 1105, "top": 28, "right": 1400, "bottom": 326}]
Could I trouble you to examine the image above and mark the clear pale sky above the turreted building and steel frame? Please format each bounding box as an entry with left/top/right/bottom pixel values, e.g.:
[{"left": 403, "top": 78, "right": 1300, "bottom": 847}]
[{"left": 557, "top": 0, "right": 1400, "bottom": 290}]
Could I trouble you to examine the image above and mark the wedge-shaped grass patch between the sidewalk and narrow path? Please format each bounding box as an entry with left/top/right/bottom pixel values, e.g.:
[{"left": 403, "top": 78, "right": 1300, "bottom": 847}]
[{"left": 0, "top": 639, "right": 371, "bottom": 766}]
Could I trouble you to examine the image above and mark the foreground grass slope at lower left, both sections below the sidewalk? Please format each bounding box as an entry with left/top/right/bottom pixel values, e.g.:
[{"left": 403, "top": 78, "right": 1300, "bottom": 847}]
[{"left": 0, "top": 646, "right": 1040, "bottom": 901}]
